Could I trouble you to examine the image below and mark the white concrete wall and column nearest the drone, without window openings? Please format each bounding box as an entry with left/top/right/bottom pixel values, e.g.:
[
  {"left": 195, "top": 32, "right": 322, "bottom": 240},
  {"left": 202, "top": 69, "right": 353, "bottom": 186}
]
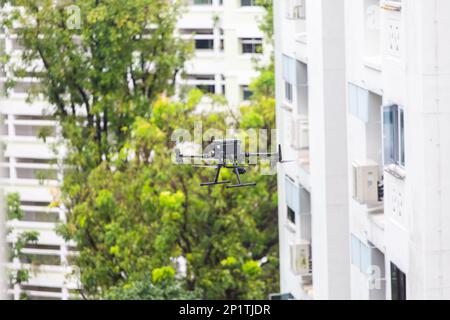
[{"left": 275, "top": 0, "right": 350, "bottom": 299}]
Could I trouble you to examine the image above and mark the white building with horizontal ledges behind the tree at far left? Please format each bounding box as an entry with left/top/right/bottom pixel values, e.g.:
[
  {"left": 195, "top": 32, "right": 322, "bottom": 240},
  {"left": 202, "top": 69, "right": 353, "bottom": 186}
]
[{"left": 0, "top": 26, "right": 76, "bottom": 300}]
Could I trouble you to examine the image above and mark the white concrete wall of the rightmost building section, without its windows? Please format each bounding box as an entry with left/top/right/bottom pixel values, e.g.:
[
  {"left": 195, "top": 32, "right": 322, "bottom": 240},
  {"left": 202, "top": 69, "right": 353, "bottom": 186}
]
[{"left": 346, "top": 0, "right": 450, "bottom": 299}]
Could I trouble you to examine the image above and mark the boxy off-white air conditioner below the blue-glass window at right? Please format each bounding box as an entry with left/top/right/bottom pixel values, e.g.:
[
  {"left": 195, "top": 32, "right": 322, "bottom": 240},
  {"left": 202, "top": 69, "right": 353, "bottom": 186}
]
[{"left": 353, "top": 160, "right": 380, "bottom": 205}]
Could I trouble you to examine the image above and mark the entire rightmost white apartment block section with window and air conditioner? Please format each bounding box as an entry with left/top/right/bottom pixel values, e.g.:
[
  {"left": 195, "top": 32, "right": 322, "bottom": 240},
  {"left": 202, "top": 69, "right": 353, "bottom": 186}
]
[{"left": 346, "top": 0, "right": 450, "bottom": 300}]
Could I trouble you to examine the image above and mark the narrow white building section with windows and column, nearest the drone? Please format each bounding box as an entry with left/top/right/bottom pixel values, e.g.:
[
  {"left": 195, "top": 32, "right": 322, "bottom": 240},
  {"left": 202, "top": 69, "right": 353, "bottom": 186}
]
[{"left": 274, "top": 0, "right": 350, "bottom": 299}]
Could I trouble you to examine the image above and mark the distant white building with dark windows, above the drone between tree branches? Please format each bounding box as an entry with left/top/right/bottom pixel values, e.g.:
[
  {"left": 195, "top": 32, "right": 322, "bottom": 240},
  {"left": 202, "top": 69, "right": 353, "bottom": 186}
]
[{"left": 178, "top": 0, "right": 272, "bottom": 107}]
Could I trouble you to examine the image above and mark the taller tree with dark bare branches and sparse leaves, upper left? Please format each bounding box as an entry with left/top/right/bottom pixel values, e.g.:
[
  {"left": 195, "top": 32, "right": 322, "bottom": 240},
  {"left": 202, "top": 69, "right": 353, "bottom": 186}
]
[{"left": 2, "top": 0, "right": 192, "bottom": 177}]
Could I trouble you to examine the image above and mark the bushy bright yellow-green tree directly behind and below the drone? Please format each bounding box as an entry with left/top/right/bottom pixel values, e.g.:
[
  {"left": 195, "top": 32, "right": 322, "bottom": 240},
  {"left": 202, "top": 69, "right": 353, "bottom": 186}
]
[{"left": 57, "top": 91, "right": 278, "bottom": 299}]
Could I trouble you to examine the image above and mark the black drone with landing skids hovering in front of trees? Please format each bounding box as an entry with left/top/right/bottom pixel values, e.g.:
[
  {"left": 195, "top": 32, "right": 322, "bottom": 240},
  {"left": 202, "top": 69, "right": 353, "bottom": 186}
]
[{"left": 175, "top": 139, "right": 292, "bottom": 189}]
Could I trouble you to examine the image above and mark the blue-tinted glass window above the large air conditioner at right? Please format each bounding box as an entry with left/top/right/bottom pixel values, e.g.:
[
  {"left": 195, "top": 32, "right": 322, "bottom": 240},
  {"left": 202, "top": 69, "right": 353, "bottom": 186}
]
[{"left": 383, "top": 105, "right": 406, "bottom": 167}]
